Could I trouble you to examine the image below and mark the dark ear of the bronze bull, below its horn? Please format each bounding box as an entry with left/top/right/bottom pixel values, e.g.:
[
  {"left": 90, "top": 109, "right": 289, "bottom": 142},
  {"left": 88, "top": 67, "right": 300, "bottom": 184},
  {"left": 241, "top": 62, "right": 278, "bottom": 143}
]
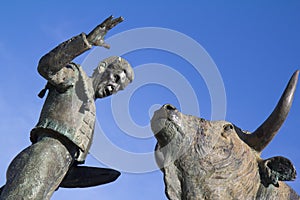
[{"left": 259, "top": 156, "right": 297, "bottom": 187}]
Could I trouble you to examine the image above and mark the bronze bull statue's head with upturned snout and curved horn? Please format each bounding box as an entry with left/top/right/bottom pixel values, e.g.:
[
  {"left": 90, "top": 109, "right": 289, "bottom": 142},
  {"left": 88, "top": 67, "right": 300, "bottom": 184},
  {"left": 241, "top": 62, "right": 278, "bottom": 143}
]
[{"left": 151, "top": 70, "right": 300, "bottom": 200}]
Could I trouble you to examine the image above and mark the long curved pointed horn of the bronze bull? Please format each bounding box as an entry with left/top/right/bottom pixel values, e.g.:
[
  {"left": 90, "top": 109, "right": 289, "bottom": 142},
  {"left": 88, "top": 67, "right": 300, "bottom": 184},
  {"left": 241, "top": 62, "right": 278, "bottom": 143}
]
[{"left": 244, "top": 70, "right": 300, "bottom": 152}]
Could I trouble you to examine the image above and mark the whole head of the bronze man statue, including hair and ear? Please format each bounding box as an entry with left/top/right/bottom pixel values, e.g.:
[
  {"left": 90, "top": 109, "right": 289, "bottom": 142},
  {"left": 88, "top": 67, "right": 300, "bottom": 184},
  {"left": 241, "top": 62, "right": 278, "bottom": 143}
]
[{"left": 92, "top": 56, "right": 134, "bottom": 98}]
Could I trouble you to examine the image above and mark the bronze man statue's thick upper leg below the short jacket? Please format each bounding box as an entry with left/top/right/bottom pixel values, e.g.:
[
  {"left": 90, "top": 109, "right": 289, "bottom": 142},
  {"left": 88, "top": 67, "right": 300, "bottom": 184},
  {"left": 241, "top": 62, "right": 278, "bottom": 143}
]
[{"left": 0, "top": 137, "right": 74, "bottom": 200}]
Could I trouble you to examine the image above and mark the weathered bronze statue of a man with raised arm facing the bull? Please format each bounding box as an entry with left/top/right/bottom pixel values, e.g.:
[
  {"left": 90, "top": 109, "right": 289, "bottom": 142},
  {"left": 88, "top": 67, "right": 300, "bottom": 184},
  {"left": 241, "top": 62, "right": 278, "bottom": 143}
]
[{"left": 0, "top": 17, "right": 133, "bottom": 200}]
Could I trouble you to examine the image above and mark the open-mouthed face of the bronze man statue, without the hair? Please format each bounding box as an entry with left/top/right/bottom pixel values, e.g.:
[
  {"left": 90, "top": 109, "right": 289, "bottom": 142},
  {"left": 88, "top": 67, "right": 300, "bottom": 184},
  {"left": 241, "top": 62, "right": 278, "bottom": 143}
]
[{"left": 95, "top": 68, "right": 131, "bottom": 98}]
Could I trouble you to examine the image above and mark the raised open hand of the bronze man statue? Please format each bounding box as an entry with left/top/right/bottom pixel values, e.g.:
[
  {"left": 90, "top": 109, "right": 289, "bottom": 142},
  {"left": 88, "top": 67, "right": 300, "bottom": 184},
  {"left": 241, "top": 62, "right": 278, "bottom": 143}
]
[{"left": 87, "top": 16, "right": 124, "bottom": 48}]
